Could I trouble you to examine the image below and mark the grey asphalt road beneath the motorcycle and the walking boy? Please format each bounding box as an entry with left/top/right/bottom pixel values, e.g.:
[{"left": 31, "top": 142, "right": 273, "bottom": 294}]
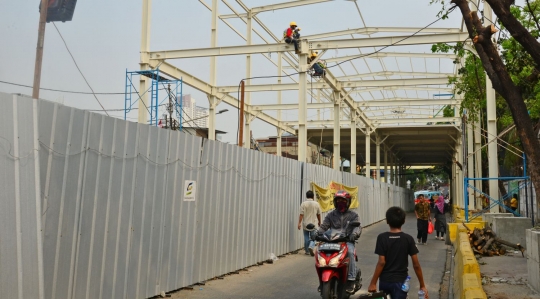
[{"left": 171, "top": 214, "right": 449, "bottom": 299}]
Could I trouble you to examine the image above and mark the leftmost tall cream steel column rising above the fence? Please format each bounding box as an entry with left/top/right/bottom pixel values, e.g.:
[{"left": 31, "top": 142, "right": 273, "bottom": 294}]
[{"left": 137, "top": 0, "right": 152, "bottom": 124}]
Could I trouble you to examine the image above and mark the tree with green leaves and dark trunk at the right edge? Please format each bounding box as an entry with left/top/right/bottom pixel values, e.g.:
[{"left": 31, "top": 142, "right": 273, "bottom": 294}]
[{"left": 431, "top": 0, "right": 540, "bottom": 213}]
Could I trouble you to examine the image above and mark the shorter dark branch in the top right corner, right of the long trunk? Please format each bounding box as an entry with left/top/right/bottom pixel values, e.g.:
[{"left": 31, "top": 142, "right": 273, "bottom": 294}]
[{"left": 486, "top": 0, "right": 540, "bottom": 66}]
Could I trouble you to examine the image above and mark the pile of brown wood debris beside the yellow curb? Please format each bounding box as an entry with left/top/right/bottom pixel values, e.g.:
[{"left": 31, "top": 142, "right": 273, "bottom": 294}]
[{"left": 467, "top": 228, "right": 525, "bottom": 256}]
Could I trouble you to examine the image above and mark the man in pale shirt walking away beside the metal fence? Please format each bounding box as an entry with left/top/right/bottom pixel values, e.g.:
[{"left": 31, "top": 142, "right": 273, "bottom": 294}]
[{"left": 298, "top": 190, "right": 321, "bottom": 256}]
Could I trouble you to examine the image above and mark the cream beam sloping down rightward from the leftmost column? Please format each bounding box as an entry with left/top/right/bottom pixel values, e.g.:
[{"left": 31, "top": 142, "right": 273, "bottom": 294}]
[{"left": 150, "top": 61, "right": 296, "bottom": 134}]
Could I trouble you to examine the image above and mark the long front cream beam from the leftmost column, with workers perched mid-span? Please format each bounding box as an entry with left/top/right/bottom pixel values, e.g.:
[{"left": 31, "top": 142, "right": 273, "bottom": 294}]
[{"left": 150, "top": 33, "right": 469, "bottom": 59}]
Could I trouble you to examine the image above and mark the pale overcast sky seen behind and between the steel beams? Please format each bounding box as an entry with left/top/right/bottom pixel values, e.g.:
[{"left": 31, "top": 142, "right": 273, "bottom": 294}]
[{"left": 0, "top": 0, "right": 461, "bottom": 143}]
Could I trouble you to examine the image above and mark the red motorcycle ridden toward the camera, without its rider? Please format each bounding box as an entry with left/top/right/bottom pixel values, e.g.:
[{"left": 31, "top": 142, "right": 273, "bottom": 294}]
[{"left": 308, "top": 222, "right": 362, "bottom": 299}]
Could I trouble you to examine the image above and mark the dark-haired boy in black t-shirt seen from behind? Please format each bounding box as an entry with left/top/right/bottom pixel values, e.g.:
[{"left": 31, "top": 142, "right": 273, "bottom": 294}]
[{"left": 368, "top": 207, "right": 429, "bottom": 299}]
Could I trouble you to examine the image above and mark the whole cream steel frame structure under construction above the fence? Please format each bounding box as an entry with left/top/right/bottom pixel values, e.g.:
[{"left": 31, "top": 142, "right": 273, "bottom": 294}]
[{"left": 139, "top": 0, "right": 486, "bottom": 194}]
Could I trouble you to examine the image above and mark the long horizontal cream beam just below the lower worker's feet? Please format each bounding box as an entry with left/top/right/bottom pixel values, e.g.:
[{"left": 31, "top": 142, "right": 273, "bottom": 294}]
[{"left": 217, "top": 78, "right": 448, "bottom": 93}]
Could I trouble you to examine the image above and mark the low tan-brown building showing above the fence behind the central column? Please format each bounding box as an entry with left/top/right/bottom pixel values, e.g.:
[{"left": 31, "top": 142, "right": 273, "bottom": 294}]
[{"left": 256, "top": 135, "right": 332, "bottom": 167}]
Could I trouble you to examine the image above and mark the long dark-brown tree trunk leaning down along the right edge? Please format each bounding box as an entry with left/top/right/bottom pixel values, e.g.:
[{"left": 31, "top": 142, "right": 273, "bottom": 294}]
[{"left": 452, "top": 0, "right": 540, "bottom": 216}]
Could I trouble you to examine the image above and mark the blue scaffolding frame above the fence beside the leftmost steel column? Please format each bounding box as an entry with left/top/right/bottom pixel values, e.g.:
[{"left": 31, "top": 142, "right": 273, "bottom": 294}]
[{"left": 124, "top": 68, "right": 183, "bottom": 129}]
